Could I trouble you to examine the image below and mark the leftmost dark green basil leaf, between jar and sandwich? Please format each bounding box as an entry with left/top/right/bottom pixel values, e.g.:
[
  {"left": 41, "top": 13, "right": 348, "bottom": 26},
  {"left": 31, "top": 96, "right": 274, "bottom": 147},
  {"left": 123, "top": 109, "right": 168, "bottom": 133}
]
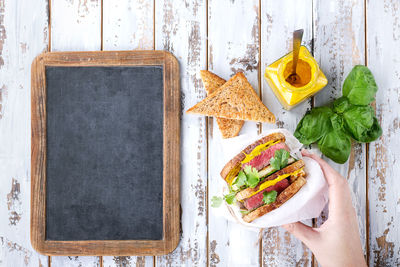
[{"left": 294, "top": 107, "right": 333, "bottom": 145}]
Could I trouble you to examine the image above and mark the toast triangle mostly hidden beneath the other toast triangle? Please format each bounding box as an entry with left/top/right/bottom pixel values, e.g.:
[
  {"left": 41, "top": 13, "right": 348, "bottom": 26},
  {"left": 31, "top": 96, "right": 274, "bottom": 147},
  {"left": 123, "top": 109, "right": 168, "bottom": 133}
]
[{"left": 200, "top": 70, "right": 244, "bottom": 138}]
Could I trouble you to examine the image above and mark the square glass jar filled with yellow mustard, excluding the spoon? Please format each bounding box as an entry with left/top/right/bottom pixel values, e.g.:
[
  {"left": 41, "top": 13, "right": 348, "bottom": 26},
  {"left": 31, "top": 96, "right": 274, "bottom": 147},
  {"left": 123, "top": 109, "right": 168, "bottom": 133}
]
[{"left": 265, "top": 46, "right": 328, "bottom": 110}]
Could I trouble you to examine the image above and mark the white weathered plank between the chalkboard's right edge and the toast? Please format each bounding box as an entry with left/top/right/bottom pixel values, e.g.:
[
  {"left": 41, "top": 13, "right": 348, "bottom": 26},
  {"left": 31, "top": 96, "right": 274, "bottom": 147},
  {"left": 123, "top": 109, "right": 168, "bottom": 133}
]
[{"left": 155, "top": 0, "right": 207, "bottom": 266}]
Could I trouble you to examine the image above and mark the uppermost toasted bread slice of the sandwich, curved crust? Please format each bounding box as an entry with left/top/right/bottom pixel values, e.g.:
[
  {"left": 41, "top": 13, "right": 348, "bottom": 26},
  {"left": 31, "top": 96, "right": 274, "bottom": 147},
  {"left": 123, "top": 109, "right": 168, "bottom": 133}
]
[{"left": 221, "top": 133, "right": 286, "bottom": 180}]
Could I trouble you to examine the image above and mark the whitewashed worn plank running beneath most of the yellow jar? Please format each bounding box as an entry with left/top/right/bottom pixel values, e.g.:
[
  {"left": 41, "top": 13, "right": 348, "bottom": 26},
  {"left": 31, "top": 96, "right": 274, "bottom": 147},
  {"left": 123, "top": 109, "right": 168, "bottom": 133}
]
[{"left": 261, "top": 0, "right": 312, "bottom": 266}]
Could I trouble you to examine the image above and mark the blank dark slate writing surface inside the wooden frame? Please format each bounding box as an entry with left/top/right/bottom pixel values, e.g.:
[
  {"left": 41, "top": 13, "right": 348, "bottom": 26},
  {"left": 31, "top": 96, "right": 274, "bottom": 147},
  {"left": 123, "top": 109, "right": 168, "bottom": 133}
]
[{"left": 46, "top": 66, "right": 163, "bottom": 240}]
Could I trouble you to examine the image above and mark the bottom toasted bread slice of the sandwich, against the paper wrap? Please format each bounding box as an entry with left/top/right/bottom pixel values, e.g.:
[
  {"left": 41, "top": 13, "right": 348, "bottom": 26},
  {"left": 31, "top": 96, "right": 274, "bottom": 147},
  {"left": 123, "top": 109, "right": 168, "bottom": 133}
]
[{"left": 243, "top": 177, "right": 307, "bottom": 223}]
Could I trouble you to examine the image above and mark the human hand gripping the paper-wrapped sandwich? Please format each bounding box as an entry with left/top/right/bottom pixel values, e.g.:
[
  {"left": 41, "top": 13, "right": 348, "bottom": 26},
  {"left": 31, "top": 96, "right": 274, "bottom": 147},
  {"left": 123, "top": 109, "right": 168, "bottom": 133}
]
[{"left": 283, "top": 150, "right": 367, "bottom": 267}]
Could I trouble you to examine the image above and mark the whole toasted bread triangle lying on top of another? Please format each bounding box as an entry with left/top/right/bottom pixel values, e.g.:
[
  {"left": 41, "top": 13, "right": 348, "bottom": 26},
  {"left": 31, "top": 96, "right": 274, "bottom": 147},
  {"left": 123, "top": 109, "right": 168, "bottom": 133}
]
[{"left": 186, "top": 72, "right": 275, "bottom": 123}]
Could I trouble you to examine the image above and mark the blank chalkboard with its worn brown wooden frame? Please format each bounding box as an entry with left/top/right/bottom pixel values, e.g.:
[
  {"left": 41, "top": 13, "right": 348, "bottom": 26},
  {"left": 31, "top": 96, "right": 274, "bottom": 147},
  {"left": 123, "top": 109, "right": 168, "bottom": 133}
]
[{"left": 31, "top": 51, "right": 179, "bottom": 255}]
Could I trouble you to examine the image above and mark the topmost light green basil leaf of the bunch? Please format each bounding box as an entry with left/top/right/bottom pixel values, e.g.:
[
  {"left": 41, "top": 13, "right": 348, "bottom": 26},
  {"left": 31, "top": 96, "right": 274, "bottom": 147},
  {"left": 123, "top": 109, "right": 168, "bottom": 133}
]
[{"left": 343, "top": 65, "right": 378, "bottom": 106}]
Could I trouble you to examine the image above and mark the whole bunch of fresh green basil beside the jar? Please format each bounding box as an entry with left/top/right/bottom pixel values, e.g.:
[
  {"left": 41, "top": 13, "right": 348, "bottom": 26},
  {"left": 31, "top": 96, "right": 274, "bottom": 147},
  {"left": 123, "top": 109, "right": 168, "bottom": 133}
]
[{"left": 294, "top": 65, "right": 382, "bottom": 164}]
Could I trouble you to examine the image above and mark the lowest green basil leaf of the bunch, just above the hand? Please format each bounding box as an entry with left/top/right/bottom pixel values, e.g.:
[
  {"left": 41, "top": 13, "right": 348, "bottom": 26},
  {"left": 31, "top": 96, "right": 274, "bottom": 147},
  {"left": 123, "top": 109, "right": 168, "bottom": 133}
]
[{"left": 318, "top": 129, "right": 351, "bottom": 164}]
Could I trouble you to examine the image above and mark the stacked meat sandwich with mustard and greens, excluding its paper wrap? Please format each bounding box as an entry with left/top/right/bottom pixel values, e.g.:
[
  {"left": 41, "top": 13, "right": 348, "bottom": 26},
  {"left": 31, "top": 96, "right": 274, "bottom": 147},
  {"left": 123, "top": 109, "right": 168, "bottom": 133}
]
[{"left": 216, "top": 133, "right": 307, "bottom": 223}]
